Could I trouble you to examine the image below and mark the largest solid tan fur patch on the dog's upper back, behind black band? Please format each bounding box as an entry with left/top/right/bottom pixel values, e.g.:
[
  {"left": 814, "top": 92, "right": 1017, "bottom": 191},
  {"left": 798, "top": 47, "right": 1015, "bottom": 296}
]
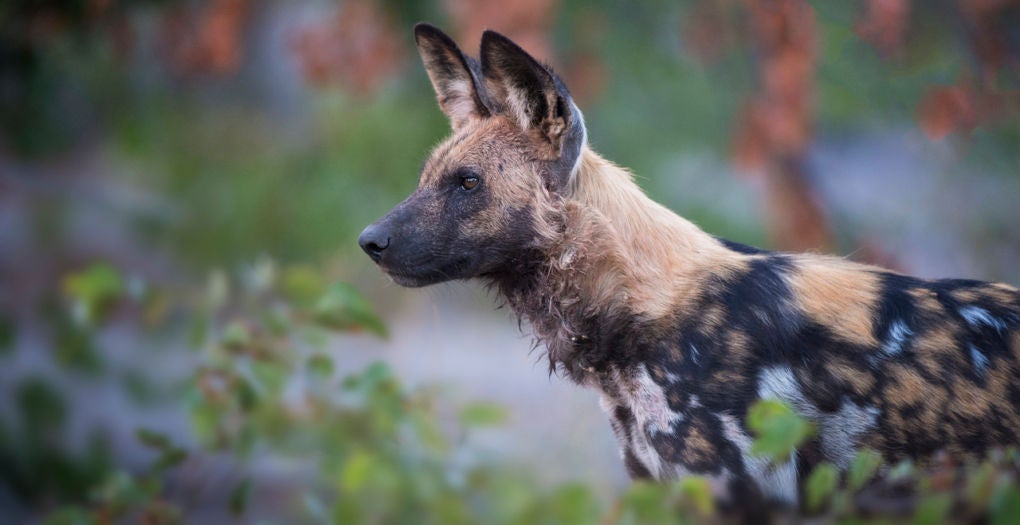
[{"left": 787, "top": 257, "right": 880, "bottom": 347}]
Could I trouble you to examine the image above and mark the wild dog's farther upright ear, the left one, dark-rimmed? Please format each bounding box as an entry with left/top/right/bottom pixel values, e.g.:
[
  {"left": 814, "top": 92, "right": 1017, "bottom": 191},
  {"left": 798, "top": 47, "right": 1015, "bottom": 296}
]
[{"left": 414, "top": 22, "right": 493, "bottom": 132}]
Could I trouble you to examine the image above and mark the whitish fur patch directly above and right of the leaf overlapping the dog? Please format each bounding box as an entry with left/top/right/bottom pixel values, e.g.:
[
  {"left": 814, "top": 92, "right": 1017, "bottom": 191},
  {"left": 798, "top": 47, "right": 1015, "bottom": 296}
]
[{"left": 758, "top": 366, "right": 880, "bottom": 468}]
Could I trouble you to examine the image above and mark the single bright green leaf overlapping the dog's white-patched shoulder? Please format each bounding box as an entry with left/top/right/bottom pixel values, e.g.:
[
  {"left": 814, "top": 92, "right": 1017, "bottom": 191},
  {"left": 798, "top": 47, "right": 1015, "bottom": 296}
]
[{"left": 748, "top": 400, "right": 814, "bottom": 463}]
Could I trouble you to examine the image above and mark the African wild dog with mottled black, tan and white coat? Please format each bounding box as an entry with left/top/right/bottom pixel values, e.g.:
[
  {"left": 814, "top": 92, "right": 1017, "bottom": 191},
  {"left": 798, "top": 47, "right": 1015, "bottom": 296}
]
[{"left": 359, "top": 24, "right": 1020, "bottom": 503}]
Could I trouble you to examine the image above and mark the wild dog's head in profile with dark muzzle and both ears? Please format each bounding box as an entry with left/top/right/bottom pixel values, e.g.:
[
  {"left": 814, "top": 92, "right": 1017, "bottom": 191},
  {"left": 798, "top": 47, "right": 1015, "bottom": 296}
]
[{"left": 358, "top": 23, "right": 585, "bottom": 286}]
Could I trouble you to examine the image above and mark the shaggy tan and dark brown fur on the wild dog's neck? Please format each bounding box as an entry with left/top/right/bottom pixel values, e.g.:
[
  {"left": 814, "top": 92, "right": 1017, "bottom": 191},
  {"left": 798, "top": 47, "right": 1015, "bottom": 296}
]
[{"left": 489, "top": 148, "right": 734, "bottom": 381}]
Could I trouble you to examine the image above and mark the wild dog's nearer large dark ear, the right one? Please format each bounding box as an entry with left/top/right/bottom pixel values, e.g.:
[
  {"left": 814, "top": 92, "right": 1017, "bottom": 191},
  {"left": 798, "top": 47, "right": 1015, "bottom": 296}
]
[{"left": 481, "top": 31, "right": 584, "bottom": 160}]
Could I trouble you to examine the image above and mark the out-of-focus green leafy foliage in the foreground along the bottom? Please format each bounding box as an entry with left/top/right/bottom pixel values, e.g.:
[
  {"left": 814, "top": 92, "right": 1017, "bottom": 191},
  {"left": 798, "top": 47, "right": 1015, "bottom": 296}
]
[{"left": 17, "top": 259, "right": 1020, "bottom": 525}]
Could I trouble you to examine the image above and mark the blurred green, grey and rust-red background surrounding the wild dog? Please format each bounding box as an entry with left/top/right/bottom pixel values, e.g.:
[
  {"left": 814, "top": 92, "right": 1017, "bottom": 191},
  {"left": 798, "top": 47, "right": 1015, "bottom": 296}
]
[{"left": 0, "top": 0, "right": 1020, "bottom": 523}]
